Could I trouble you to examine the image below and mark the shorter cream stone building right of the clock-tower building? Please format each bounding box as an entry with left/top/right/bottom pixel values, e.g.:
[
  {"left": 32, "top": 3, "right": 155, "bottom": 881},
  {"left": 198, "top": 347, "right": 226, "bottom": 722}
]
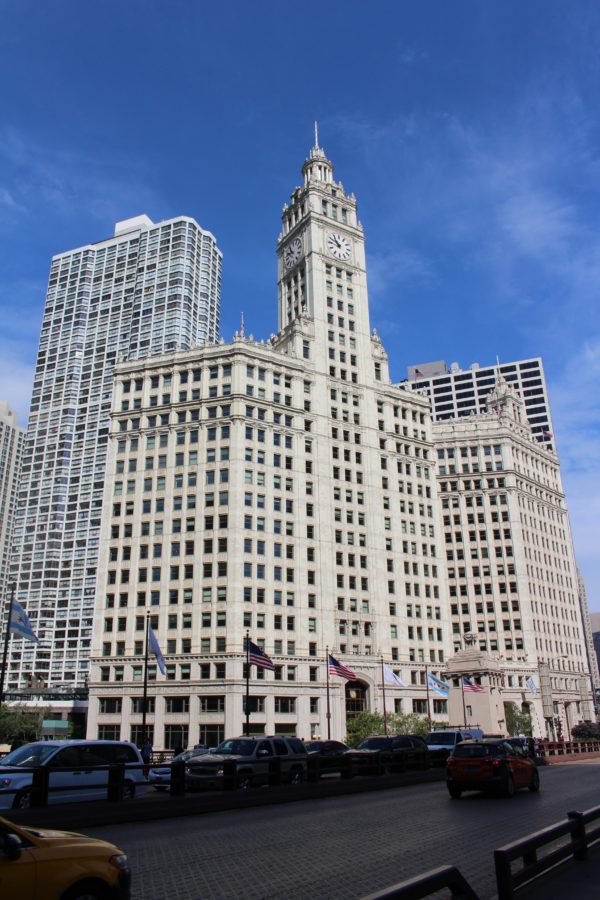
[{"left": 433, "top": 375, "right": 595, "bottom": 736}]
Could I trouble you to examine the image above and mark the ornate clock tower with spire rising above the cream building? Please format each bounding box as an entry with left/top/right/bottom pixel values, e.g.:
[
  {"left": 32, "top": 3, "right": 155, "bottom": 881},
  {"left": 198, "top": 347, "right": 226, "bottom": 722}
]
[{"left": 277, "top": 124, "right": 380, "bottom": 384}]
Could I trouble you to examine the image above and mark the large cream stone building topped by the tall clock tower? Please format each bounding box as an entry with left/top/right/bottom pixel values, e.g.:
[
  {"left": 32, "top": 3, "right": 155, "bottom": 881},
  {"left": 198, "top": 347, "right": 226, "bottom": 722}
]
[{"left": 88, "top": 141, "right": 452, "bottom": 747}]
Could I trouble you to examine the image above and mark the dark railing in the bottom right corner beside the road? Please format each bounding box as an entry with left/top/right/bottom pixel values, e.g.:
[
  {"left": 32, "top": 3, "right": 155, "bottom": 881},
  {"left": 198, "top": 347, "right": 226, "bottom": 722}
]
[{"left": 494, "top": 806, "right": 600, "bottom": 900}]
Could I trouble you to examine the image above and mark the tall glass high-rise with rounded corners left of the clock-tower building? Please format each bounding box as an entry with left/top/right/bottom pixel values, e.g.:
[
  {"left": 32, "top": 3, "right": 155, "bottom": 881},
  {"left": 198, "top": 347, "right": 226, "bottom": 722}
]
[{"left": 7, "top": 216, "right": 222, "bottom": 689}]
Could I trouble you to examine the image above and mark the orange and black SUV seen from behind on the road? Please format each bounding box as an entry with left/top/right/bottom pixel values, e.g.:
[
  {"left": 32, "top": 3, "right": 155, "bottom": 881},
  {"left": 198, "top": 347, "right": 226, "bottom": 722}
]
[{"left": 446, "top": 738, "right": 540, "bottom": 799}]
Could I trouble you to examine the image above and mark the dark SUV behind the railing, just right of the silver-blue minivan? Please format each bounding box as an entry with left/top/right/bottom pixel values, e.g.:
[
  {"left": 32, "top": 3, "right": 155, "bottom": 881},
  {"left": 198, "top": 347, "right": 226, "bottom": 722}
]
[{"left": 185, "top": 737, "right": 308, "bottom": 790}]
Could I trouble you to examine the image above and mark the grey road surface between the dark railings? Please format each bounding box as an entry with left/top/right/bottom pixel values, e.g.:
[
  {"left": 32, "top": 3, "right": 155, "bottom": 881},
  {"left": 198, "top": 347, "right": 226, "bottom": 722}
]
[{"left": 88, "top": 764, "right": 600, "bottom": 900}]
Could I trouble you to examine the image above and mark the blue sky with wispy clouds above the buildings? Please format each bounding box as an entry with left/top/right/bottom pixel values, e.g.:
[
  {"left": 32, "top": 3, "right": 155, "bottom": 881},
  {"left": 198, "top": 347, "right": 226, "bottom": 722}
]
[{"left": 0, "top": 0, "right": 600, "bottom": 610}]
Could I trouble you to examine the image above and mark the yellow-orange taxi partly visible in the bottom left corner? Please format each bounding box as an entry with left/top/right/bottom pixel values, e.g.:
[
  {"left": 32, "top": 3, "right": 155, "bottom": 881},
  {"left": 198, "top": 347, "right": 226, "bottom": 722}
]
[{"left": 0, "top": 818, "right": 131, "bottom": 900}]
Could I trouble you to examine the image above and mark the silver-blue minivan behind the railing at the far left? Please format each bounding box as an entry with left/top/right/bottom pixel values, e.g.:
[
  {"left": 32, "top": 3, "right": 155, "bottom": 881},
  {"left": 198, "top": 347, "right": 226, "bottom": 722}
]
[{"left": 0, "top": 740, "right": 146, "bottom": 809}]
